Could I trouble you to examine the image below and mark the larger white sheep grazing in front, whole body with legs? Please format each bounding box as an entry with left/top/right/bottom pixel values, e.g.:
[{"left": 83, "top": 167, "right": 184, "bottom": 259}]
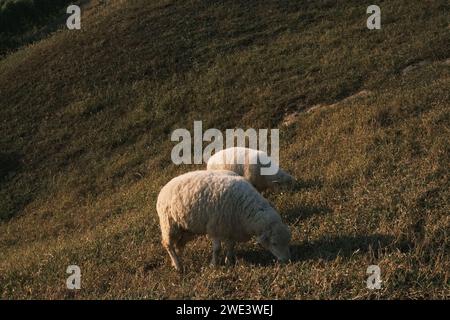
[{"left": 156, "top": 170, "right": 291, "bottom": 270}]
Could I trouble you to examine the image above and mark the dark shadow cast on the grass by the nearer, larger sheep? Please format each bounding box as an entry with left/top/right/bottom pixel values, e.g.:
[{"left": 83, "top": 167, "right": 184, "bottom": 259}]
[{"left": 238, "top": 234, "right": 402, "bottom": 266}]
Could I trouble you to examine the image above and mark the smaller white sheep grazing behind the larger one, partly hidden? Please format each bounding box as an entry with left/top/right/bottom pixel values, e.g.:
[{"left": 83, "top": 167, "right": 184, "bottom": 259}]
[{"left": 207, "top": 147, "right": 295, "bottom": 192}]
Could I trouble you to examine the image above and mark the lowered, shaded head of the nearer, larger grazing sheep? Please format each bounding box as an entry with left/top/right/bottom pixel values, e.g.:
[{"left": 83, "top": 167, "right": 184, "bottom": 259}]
[{"left": 258, "top": 222, "right": 291, "bottom": 262}]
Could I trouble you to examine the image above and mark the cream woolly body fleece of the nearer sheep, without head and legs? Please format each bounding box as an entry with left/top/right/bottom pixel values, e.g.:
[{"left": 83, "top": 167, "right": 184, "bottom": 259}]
[{"left": 157, "top": 171, "right": 281, "bottom": 245}]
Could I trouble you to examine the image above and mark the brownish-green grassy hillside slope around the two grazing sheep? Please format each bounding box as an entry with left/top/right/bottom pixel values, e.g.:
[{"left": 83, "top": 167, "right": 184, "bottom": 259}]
[{"left": 0, "top": 0, "right": 450, "bottom": 299}]
